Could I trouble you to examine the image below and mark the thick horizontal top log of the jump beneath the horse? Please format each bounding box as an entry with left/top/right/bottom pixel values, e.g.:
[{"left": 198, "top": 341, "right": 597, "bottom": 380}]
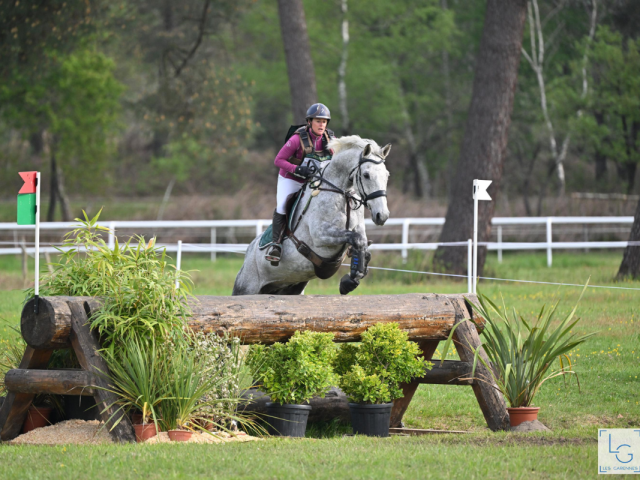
[{"left": 21, "top": 293, "right": 482, "bottom": 348}]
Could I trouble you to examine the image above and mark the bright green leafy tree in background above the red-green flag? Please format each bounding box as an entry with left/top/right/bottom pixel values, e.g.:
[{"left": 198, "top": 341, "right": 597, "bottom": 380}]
[{"left": 0, "top": 49, "right": 124, "bottom": 221}]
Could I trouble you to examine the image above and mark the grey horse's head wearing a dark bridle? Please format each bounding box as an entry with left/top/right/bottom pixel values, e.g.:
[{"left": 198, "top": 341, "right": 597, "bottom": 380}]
[{"left": 352, "top": 143, "right": 391, "bottom": 225}]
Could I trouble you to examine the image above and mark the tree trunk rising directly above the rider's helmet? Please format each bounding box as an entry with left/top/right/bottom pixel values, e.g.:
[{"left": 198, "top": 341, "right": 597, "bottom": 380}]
[{"left": 278, "top": 0, "right": 318, "bottom": 123}]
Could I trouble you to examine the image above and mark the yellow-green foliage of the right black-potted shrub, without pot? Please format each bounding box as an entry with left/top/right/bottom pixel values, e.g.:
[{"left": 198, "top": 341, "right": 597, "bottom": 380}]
[{"left": 334, "top": 323, "right": 432, "bottom": 403}]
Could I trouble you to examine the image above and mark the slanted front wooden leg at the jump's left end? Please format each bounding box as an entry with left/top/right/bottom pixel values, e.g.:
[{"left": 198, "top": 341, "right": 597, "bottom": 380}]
[{"left": 69, "top": 301, "right": 136, "bottom": 442}]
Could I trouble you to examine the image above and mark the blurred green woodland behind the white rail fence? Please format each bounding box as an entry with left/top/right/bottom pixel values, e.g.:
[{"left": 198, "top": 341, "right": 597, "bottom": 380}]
[{"left": 0, "top": 0, "right": 640, "bottom": 276}]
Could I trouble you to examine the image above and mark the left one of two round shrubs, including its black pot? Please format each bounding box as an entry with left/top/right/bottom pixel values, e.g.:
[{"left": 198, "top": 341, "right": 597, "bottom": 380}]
[{"left": 247, "top": 331, "right": 337, "bottom": 437}]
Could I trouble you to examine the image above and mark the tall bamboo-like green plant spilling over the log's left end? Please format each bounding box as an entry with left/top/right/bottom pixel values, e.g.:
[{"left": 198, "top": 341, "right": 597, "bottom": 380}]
[{"left": 33, "top": 212, "right": 193, "bottom": 348}]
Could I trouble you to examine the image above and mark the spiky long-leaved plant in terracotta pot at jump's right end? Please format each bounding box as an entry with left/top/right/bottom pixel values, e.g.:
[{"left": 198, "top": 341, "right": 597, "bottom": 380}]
[{"left": 442, "top": 286, "right": 595, "bottom": 427}]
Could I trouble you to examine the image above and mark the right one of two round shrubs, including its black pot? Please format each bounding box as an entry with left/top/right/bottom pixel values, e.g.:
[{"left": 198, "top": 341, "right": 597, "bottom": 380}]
[{"left": 335, "top": 323, "right": 431, "bottom": 437}]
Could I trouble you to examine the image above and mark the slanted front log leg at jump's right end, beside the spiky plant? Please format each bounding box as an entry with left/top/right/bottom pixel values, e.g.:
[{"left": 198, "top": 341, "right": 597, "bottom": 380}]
[{"left": 453, "top": 300, "right": 509, "bottom": 432}]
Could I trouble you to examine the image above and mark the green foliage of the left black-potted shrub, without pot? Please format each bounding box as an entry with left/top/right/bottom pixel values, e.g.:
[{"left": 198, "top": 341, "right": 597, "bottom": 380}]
[{"left": 247, "top": 331, "right": 337, "bottom": 404}]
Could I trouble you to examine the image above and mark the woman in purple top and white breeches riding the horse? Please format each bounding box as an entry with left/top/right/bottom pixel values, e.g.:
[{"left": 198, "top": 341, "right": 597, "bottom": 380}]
[{"left": 265, "top": 103, "right": 334, "bottom": 267}]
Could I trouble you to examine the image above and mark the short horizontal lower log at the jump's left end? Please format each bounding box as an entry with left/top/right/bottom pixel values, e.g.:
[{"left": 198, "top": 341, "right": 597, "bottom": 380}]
[{"left": 4, "top": 369, "right": 95, "bottom": 396}]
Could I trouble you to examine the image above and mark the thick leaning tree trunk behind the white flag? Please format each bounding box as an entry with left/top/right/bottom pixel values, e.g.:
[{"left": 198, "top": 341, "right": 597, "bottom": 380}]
[{"left": 434, "top": 0, "right": 527, "bottom": 274}]
